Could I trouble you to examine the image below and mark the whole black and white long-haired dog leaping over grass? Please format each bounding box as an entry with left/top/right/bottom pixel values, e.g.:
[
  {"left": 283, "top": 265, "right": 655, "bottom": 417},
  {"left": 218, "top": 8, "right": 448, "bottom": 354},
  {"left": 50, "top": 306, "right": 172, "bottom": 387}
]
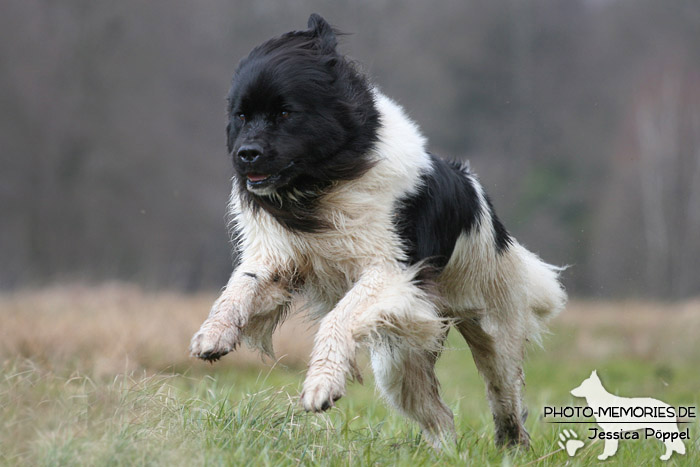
[{"left": 190, "top": 14, "right": 566, "bottom": 446}]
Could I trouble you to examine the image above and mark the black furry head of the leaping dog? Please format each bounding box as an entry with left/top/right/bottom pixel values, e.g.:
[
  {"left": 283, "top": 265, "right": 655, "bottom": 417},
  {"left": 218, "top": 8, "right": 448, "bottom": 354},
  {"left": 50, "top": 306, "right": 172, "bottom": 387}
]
[{"left": 226, "top": 14, "right": 379, "bottom": 229}]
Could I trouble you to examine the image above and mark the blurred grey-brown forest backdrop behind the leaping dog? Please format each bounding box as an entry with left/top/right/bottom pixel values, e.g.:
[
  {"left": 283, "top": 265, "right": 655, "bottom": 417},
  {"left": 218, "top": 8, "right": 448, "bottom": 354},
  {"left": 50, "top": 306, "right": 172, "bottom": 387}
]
[{"left": 0, "top": 0, "right": 700, "bottom": 299}]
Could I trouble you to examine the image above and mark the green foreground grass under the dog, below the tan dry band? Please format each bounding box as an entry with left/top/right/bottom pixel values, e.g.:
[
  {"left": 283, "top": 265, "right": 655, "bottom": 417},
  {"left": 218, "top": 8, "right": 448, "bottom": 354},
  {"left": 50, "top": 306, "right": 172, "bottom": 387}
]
[{"left": 0, "top": 328, "right": 700, "bottom": 466}]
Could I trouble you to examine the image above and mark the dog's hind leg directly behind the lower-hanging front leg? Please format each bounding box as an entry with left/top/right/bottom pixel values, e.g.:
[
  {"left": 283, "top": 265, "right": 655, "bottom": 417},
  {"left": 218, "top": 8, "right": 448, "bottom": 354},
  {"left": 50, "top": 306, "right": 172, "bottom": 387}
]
[{"left": 371, "top": 336, "right": 455, "bottom": 449}]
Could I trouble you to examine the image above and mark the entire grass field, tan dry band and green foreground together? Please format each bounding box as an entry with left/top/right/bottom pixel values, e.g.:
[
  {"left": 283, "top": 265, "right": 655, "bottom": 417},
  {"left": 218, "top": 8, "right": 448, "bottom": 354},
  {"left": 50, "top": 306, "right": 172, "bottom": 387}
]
[{"left": 0, "top": 285, "right": 700, "bottom": 466}]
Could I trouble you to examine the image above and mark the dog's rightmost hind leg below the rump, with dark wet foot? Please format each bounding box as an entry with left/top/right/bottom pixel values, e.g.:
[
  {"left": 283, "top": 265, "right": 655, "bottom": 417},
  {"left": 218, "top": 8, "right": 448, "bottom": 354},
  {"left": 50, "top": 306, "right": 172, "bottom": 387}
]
[{"left": 456, "top": 318, "right": 530, "bottom": 447}]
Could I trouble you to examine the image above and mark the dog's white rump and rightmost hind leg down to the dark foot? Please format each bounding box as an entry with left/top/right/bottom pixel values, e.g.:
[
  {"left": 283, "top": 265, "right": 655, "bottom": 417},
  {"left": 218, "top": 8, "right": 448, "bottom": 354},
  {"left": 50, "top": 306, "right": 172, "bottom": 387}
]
[{"left": 448, "top": 234, "right": 566, "bottom": 446}]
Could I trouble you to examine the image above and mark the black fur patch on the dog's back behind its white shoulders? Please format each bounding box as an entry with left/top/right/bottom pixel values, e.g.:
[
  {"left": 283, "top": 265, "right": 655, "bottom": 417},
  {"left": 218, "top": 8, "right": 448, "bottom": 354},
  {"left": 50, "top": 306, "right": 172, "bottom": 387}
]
[{"left": 395, "top": 155, "right": 511, "bottom": 272}]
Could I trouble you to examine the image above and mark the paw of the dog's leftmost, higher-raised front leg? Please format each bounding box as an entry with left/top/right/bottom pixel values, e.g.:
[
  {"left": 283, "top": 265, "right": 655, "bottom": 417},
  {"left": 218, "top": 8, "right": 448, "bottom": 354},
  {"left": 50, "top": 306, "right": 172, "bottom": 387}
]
[{"left": 190, "top": 316, "right": 241, "bottom": 362}]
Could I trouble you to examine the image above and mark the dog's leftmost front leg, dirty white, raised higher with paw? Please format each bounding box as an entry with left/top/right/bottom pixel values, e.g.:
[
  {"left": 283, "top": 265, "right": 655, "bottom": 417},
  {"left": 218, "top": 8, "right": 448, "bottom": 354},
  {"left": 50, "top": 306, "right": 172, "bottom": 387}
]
[{"left": 190, "top": 263, "right": 289, "bottom": 361}]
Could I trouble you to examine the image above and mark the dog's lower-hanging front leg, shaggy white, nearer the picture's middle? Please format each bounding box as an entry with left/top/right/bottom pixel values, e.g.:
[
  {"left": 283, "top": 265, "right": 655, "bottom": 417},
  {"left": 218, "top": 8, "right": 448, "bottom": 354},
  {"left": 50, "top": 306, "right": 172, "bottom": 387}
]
[{"left": 301, "top": 266, "right": 446, "bottom": 411}]
